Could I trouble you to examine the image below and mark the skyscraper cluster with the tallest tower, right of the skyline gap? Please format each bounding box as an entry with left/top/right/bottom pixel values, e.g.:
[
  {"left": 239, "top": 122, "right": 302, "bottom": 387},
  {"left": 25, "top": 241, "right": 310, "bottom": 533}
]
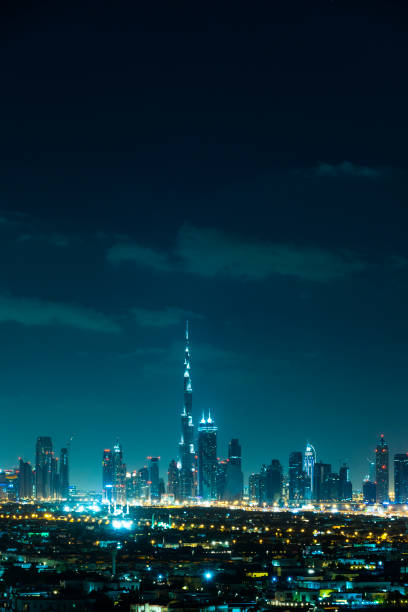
[{"left": 95, "top": 324, "right": 408, "bottom": 507}]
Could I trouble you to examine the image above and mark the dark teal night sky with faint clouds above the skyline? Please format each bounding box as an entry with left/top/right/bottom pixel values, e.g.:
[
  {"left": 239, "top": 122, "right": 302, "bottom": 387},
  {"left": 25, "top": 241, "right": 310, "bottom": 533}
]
[{"left": 0, "top": 0, "right": 408, "bottom": 488}]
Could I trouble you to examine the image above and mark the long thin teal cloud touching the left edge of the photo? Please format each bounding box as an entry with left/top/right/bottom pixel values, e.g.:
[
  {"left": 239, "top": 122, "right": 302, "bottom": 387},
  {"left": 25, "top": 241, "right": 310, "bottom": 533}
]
[{"left": 0, "top": 295, "right": 120, "bottom": 333}]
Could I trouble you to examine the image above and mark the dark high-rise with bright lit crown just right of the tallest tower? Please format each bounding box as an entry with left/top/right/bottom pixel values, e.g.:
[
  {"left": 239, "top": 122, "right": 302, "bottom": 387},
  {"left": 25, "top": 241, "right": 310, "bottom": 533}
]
[{"left": 197, "top": 414, "right": 218, "bottom": 501}]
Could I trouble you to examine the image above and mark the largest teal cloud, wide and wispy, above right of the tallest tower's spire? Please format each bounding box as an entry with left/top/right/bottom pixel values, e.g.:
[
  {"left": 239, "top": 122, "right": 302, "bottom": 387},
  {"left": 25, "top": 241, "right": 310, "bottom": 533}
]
[{"left": 177, "top": 226, "right": 366, "bottom": 282}]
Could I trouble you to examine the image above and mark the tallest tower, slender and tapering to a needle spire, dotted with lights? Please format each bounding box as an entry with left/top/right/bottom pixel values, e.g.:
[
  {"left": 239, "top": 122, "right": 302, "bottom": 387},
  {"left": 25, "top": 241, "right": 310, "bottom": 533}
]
[{"left": 179, "top": 321, "right": 196, "bottom": 500}]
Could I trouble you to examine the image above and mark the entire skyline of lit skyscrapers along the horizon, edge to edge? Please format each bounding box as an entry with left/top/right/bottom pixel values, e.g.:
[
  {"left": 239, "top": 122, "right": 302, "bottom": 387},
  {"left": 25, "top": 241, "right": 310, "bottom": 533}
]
[{"left": 0, "top": 324, "right": 408, "bottom": 507}]
